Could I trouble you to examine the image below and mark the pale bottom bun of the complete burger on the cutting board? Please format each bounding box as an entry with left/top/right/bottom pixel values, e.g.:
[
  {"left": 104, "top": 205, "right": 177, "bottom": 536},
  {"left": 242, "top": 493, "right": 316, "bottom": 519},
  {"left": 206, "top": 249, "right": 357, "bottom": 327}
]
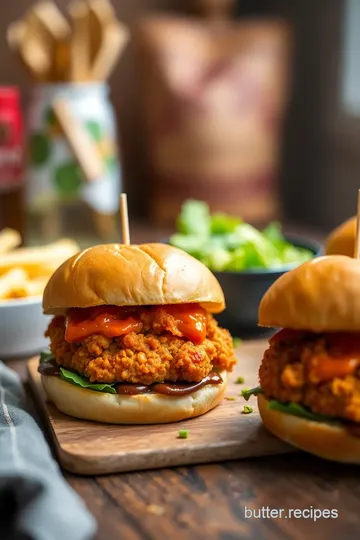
[{"left": 41, "top": 371, "right": 227, "bottom": 424}]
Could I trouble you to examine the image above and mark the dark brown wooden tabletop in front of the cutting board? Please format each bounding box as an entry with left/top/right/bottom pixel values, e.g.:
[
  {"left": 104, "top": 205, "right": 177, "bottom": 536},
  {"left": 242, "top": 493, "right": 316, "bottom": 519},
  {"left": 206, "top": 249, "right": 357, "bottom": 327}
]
[{"left": 8, "top": 354, "right": 360, "bottom": 540}]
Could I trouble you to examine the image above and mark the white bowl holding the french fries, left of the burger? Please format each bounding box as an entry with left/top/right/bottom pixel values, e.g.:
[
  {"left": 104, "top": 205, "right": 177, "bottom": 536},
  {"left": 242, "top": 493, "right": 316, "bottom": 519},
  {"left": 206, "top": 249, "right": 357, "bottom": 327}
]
[{"left": 0, "top": 296, "right": 51, "bottom": 359}]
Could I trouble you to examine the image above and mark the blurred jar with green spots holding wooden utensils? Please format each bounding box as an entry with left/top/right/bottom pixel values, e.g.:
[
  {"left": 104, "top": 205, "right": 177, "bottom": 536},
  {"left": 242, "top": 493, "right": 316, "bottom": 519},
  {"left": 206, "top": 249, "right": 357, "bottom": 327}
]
[{"left": 27, "top": 82, "right": 121, "bottom": 243}]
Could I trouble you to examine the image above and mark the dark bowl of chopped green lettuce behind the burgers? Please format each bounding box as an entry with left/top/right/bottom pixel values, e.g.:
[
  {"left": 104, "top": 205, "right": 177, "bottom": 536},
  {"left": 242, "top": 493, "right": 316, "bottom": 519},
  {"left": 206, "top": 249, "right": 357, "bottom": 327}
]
[{"left": 169, "top": 200, "right": 323, "bottom": 335}]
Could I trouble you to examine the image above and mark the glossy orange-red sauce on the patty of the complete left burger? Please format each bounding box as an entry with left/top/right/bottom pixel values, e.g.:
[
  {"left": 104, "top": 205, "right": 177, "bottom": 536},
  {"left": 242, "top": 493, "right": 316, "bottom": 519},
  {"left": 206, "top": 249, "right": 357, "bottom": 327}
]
[{"left": 65, "top": 304, "right": 206, "bottom": 343}]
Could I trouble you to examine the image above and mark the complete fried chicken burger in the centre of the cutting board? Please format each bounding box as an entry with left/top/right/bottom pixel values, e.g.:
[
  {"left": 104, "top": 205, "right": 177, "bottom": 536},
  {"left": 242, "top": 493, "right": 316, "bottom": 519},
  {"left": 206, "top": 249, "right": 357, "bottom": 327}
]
[{"left": 39, "top": 244, "right": 235, "bottom": 424}]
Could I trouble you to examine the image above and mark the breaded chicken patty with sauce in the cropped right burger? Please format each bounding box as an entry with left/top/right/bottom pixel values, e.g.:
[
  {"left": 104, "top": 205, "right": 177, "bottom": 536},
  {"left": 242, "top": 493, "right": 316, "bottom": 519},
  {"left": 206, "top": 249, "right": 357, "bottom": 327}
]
[{"left": 259, "top": 333, "right": 360, "bottom": 422}]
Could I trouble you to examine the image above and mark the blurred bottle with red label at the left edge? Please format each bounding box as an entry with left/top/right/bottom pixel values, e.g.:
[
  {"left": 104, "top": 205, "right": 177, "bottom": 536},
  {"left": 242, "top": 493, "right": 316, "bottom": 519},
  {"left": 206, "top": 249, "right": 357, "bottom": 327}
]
[{"left": 0, "top": 87, "right": 25, "bottom": 236}]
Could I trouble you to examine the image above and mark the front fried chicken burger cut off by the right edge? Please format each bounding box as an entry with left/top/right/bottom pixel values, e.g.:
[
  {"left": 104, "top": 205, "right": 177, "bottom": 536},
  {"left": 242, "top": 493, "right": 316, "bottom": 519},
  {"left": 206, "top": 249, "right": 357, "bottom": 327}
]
[{"left": 244, "top": 255, "right": 360, "bottom": 463}]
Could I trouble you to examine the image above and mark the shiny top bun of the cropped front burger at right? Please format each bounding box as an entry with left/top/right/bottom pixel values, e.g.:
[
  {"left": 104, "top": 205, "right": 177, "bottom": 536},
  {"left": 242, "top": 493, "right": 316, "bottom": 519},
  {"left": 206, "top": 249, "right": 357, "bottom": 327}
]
[{"left": 259, "top": 255, "right": 360, "bottom": 332}]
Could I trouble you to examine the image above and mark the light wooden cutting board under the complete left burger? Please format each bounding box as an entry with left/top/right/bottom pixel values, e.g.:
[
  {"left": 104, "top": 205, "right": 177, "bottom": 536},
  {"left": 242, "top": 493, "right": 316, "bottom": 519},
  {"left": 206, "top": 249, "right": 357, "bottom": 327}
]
[{"left": 28, "top": 341, "right": 293, "bottom": 475}]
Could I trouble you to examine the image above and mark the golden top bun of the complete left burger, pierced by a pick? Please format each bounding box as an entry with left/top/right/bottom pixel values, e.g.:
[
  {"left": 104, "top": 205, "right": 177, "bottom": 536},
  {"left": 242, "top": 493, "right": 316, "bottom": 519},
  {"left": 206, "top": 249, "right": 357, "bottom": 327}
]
[{"left": 43, "top": 244, "right": 225, "bottom": 315}]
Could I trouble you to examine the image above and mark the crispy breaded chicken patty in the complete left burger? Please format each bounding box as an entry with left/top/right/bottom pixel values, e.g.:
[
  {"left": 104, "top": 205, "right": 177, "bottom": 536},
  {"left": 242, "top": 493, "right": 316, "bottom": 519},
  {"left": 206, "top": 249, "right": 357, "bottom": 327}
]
[{"left": 46, "top": 310, "right": 236, "bottom": 385}]
